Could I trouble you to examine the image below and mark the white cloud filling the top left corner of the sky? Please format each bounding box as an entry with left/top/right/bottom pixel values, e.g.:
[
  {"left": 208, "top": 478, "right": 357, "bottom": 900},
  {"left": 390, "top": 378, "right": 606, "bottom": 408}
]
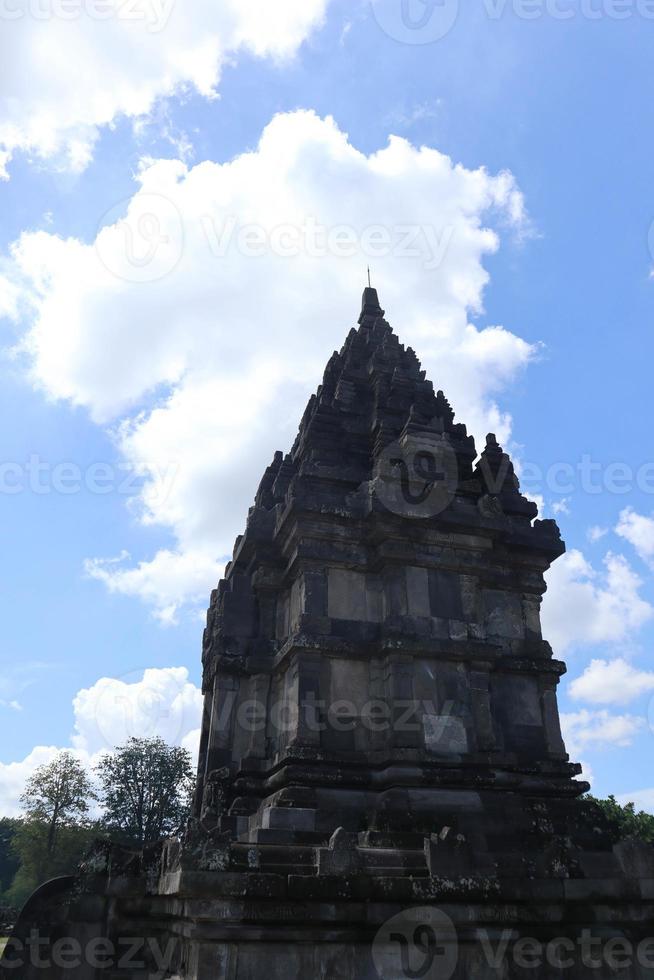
[{"left": 0, "top": 0, "right": 328, "bottom": 179}]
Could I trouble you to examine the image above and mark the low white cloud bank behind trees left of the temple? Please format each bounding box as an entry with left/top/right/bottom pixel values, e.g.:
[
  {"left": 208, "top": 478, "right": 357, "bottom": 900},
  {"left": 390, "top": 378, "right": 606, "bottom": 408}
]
[{"left": 0, "top": 667, "right": 202, "bottom": 817}]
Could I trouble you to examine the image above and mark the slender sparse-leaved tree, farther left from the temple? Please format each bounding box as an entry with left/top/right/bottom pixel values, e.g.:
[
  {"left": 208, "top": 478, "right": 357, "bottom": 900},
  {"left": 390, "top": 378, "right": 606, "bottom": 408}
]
[{"left": 20, "top": 752, "right": 96, "bottom": 858}]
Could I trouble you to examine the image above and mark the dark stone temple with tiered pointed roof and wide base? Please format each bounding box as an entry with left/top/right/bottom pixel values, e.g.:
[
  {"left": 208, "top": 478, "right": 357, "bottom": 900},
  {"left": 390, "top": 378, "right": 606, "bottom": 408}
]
[{"left": 3, "top": 288, "right": 654, "bottom": 980}]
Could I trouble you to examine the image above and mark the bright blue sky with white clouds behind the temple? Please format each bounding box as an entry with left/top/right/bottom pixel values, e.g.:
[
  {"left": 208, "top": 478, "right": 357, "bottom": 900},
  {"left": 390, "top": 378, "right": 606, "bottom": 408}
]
[{"left": 0, "top": 0, "right": 654, "bottom": 812}]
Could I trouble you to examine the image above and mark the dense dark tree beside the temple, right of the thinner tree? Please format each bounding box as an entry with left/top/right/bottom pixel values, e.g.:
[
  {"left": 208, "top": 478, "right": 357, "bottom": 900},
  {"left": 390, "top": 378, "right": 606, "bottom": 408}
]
[{"left": 96, "top": 738, "right": 193, "bottom": 847}]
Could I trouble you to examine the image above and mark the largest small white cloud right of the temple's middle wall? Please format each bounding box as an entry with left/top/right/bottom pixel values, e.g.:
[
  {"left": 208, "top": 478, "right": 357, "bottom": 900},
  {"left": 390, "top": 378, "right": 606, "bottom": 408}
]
[{"left": 543, "top": 550, "right": 654, "bottom": 654}]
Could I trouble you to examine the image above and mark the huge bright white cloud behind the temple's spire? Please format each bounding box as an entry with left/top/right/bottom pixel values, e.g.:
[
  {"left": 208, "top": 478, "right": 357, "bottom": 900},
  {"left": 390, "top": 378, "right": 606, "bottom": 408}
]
[{"left": 4, "top": 112, "right": 536, "bottom": 621}]
